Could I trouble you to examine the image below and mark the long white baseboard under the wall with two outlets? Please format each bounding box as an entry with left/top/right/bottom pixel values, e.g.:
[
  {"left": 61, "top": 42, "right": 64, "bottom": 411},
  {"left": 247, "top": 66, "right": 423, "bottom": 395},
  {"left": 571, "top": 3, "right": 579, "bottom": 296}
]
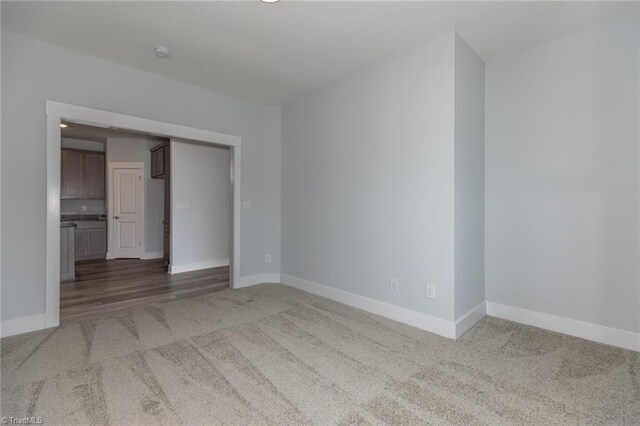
[{"left": 281, "top": 274, "right": 456, "bottom": 339}]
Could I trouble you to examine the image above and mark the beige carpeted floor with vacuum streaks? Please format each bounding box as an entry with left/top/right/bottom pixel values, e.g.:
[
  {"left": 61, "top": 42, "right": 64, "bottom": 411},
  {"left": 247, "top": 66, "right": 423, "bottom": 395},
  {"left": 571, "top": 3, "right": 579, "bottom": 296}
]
[{"left": 1, "top": 284, "right": 640, "bottom": 425}]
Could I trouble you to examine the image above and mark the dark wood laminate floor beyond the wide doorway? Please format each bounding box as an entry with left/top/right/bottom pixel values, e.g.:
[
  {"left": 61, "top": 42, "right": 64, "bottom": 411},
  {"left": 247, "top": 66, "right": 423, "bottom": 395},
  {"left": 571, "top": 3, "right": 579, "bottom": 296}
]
[{"left": 60, "top": 259, "right": 229, "bottom": 320}]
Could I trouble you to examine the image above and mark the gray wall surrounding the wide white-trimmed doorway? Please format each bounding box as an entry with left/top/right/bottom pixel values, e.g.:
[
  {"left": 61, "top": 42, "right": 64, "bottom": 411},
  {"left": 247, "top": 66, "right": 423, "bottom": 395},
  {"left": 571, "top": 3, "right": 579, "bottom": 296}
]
[{"left": 1, "top": 31, "right": 281, "bottom": 320}]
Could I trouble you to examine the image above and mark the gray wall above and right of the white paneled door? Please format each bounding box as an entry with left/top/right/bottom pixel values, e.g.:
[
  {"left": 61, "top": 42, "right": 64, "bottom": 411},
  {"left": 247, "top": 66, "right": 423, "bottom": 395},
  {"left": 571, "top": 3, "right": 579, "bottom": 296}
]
[{"left": 106, "top": 135, "right": 164, "bottom": 257}]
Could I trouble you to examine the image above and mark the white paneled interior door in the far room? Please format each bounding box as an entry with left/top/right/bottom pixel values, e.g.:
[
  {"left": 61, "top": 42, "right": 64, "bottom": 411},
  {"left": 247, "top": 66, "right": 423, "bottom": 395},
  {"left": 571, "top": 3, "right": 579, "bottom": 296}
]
[{"left": 109, "top": 167, "right": 144, "bottom": 258}]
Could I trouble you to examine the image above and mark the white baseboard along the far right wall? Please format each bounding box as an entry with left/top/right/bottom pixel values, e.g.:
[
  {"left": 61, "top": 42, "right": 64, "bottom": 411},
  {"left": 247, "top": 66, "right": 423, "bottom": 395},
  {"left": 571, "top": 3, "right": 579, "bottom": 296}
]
[{"left": 487, "top": 302, "right": 640, "bottom": 352}]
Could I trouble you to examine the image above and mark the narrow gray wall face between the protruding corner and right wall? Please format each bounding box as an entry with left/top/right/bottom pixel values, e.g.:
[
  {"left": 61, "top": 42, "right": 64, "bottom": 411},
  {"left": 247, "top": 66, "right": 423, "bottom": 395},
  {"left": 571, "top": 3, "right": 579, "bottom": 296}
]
[{"left": 454, "top": 34, "right": 485, "bottom": 319}]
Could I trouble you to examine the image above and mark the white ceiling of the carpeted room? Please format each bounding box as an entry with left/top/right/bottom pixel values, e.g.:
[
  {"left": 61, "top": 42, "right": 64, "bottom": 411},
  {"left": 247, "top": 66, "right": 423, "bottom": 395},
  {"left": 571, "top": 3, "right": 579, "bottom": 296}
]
[{"left": 2, "top": 0, "right": 638, "bottom": 103}]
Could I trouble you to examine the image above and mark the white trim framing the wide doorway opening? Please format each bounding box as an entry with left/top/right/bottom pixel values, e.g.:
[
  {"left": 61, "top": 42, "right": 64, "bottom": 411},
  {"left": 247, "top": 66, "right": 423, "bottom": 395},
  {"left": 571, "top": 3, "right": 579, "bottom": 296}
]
[{"left": 45, "top": 100, "right": 242, "bottom": 328}]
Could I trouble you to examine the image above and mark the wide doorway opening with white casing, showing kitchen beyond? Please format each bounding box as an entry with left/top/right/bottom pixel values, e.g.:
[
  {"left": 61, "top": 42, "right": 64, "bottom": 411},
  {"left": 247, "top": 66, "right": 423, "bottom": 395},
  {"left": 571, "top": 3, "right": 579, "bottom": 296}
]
[{"left": 46, "top": 102, "right": 240, "bottom": 327}]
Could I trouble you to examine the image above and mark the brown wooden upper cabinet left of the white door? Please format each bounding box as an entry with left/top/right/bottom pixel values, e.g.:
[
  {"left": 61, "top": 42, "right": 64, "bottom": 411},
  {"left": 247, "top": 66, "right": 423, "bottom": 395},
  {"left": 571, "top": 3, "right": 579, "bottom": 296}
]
[{"left": 60, "top": 149, "right": 104, "bottom": 200}]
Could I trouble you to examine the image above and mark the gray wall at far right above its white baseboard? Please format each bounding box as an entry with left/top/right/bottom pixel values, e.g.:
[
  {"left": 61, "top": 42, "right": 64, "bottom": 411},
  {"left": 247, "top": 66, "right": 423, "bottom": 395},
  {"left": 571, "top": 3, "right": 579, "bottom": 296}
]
[{"left": 485, "top": 15, "right": 640, "bottom": 332}]
